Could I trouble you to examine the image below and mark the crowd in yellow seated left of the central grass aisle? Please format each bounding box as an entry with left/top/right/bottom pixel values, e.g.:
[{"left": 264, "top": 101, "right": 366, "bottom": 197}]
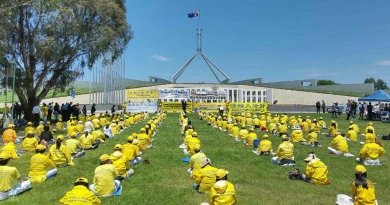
[{"left": 0, "top": 109, "right": 166, "bottom": 204}]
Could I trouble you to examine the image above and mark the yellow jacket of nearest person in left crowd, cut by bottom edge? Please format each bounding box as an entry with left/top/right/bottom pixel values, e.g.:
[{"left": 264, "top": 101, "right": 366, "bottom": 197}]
[{"left": 60, "top": 185, "right": 101, "bottom": 205}]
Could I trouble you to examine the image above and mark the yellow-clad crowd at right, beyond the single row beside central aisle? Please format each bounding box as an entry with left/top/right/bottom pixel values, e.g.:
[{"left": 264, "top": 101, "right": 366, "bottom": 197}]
[{"left": 198, "top": 111, "right": 385, "bottom": 204}]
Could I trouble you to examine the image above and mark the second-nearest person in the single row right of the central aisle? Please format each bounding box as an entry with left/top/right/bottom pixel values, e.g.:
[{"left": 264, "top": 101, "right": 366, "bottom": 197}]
[{"left": 193, "top": 158, "right": 218, "bottom": 193}]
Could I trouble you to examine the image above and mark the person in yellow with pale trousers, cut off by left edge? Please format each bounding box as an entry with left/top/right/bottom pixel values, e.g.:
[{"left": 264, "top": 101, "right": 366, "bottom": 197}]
[{"left": 0, "top": 153, "right": 31, "bottom": 201}]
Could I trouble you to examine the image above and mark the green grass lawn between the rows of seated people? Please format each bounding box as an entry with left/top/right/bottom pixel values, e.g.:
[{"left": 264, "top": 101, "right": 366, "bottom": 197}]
[{"left": 1, "top": 114, "right": 390, "bottom": 205}]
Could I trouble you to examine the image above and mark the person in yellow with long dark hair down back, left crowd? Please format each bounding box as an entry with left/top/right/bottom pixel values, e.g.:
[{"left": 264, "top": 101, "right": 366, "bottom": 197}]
[{"left": 48, "top": 135, "right": 74, "bottom": 167}]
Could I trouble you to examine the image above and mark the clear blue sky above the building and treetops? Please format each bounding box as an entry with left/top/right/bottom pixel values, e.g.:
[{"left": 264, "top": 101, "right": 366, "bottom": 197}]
[{"left": 87, "top": 0, "right": 390, "bottom": 84}]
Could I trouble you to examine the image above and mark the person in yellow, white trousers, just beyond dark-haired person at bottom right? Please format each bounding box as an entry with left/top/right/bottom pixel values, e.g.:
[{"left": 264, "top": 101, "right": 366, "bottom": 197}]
[{"left": 356, "top": 142, "right": 385, "bottom": 165}]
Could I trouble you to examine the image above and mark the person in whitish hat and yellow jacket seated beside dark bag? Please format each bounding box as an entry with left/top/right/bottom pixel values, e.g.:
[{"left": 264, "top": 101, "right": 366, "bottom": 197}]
[{"left": 302, "top": 152, "right": 330, "bottom": 185}]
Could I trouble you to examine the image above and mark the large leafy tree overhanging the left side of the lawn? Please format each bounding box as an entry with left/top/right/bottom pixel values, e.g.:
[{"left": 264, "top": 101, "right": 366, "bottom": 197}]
[{"left": 0, "top": 0, "right": 132, "bottom": 119}]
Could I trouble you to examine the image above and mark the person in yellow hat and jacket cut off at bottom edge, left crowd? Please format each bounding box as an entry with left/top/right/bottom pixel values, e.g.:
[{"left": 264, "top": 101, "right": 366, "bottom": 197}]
[{"left": 60, "top": 177, "right": 101, "bottom": 205}]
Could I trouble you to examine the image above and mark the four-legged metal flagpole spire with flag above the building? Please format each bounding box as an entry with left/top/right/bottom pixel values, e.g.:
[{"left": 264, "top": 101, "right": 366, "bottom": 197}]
[{"left": 172, "top": 10, "right": 230, "bottom": 83}]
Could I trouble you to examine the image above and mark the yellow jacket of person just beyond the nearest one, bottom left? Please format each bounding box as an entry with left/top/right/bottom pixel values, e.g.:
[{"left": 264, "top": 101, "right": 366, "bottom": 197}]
[{"left": 93, "top": 164, "right": 118, "bottom": 196}]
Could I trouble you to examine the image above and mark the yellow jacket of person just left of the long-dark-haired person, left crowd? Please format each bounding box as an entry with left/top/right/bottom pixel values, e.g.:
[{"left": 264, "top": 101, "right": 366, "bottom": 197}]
[{"left": 28, "top": 153, "right": 56, "bottom": 183}]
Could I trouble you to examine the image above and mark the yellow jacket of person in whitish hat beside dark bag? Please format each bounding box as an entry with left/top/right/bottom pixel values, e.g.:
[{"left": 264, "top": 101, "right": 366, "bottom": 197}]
[{"left": 305, "top": 159, "right": 329, "bottom": 184}]
